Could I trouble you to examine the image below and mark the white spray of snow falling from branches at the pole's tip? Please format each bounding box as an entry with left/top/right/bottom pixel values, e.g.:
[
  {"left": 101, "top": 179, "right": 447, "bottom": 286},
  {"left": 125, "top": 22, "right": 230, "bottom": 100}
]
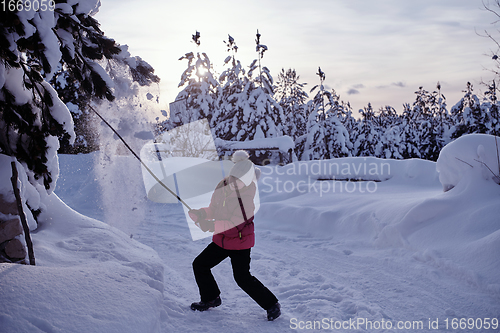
[{"left": 90, "top": 87, "right": 187, "bottom": 236}]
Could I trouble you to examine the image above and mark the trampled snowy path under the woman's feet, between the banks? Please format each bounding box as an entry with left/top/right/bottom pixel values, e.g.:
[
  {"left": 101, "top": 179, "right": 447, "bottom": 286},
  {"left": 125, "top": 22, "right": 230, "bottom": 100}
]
[{"left": 128, "top": 201, "right": 500, "bottom": 332}]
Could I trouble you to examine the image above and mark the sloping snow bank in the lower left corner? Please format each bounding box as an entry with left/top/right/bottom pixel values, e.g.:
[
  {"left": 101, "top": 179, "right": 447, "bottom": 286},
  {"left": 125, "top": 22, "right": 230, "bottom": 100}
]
[{"left": 0, "top": 185, "right": 163, "bottom": 333}]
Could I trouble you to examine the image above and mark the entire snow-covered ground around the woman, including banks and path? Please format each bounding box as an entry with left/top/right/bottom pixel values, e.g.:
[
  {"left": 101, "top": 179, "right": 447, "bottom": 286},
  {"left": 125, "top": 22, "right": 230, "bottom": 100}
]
[{"left": 0, "top": 134, "right": 500, "bottom": 333}]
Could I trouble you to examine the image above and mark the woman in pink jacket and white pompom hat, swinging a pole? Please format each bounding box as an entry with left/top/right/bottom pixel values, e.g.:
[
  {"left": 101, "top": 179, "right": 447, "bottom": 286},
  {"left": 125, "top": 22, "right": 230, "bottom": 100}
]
[{"left": 189, "top": 150, "right": 281, "bottom": 320}]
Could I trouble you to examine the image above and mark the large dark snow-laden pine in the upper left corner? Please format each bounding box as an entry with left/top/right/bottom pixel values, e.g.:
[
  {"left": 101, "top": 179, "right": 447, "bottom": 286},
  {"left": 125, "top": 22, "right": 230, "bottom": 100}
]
[{"left": 0, "top": 0, "right": 139, "bottom": 193}]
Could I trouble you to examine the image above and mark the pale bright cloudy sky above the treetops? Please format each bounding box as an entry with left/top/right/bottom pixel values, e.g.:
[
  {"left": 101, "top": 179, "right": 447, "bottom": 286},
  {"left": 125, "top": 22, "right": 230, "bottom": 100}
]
[{"left": 95, "top": 0, "right": 500, "bottom": 115}]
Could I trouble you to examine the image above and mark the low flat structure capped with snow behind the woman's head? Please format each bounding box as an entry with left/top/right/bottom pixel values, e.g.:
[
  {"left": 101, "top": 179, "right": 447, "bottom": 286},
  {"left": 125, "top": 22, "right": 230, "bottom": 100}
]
[{"left": 215, "top": 135, "right": 295, "bottom": 164}]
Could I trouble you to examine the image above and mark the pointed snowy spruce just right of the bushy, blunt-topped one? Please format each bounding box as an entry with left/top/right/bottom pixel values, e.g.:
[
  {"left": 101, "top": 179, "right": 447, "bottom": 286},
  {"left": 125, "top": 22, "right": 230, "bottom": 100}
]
[{"left": 303, "top": 68, "right": 351, "bottom": 160}]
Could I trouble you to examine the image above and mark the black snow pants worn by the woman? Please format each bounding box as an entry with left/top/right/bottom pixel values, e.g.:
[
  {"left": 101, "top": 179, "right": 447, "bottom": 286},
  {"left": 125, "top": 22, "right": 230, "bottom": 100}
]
[{"left": 193, "top": 242, "right": 278, "bottom": 310}]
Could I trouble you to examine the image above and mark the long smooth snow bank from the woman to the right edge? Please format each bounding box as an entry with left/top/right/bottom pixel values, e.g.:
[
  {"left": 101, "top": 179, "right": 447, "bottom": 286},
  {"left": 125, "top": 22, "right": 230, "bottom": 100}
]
[{"left": 256, "top": 153, "right": 500, "bottom": 295}]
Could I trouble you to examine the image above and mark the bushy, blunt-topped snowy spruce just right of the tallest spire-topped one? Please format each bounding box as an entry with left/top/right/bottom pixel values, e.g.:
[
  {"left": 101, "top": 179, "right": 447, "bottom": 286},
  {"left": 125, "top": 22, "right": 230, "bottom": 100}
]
[{"left": 274, "top": 69, "right": 308, "bottom": 156}]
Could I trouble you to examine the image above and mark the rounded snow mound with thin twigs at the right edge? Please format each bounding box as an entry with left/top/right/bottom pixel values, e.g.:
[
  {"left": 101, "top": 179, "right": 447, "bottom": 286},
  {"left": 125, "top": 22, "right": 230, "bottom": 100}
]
[{"left": 437, "top": 134, "right": 500, "bottom": 191}]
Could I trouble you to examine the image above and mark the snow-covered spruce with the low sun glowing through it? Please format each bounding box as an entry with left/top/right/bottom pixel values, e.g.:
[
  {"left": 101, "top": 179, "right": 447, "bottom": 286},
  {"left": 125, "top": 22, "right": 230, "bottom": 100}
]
[{"left": 169, "top": 31, "right": 219, "bottom": 127}]
